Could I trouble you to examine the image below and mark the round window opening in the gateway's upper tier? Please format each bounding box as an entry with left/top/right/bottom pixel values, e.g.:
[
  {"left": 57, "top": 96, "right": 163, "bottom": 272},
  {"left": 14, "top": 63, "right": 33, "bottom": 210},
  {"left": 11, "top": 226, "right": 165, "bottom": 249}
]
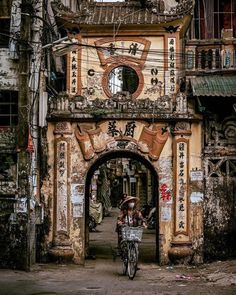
[{"left": 108, "top": 66, "right": 139, "bottom": 94}]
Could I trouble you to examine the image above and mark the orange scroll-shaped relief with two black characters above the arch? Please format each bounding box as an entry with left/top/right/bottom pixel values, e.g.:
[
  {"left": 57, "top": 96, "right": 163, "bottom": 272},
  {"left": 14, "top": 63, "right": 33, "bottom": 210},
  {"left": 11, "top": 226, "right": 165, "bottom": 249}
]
[{"left": 75, "top": 121, "right": 169, "bottom": 161}]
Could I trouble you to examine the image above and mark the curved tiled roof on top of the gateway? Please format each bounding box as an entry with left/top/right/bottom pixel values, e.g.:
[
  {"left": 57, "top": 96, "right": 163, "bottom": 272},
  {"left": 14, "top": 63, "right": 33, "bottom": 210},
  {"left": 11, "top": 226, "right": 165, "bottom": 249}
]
[{"left": 54, "top": 0, "right": 193, "bottom": 25}]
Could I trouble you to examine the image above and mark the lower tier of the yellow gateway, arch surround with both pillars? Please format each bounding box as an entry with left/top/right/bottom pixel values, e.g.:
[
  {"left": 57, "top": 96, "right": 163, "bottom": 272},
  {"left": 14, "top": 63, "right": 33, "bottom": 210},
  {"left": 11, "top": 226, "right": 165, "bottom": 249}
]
[{"left": 44, "top": 116, "right": 202, "bottom": 263}]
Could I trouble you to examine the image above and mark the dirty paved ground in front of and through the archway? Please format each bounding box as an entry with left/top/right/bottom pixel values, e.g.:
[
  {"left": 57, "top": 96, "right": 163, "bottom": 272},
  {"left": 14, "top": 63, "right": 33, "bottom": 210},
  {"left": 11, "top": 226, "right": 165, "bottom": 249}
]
[{"left": 0, "top": 209, "right": 236, "bottom": 295}]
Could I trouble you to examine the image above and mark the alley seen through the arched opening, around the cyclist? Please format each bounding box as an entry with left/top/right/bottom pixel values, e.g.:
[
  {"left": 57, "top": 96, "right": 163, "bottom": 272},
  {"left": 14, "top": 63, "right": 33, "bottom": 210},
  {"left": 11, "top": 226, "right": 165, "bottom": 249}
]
[{"left": 85, "top": 151, "right": 159, "bottom": 263}]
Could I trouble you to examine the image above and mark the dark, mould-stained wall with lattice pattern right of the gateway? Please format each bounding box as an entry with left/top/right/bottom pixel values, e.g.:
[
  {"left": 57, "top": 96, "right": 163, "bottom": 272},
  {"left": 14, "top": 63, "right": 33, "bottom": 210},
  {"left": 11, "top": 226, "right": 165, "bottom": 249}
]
[{"left": 204, "top": 113, "right": 236, "bottom": 260}]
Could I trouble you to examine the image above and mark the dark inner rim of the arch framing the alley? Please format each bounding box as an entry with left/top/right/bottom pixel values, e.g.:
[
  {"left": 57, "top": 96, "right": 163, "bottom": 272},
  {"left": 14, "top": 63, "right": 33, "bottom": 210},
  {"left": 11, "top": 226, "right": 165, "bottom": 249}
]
[{"left": 85, "top": 150, "right": 159, "bottom": 262}]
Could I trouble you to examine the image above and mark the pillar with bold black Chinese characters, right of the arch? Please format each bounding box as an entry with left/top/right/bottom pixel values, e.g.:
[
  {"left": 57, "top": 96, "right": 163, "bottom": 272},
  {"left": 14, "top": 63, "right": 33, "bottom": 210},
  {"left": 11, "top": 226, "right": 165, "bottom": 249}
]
[{"left": 168, "top": 122, "right": 193, "bottom": 263}]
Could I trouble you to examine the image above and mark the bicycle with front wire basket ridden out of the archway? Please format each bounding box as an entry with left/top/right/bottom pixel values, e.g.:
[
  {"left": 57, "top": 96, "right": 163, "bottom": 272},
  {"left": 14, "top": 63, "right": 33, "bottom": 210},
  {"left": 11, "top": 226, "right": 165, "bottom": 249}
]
[{"left": 120, "top": 226, "right": 143, "bottom": 280}]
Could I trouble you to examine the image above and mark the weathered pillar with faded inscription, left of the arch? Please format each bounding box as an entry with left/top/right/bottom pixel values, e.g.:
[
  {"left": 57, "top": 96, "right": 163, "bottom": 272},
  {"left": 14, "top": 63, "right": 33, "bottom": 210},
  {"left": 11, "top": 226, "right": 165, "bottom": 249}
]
[{"left": 49, "top": 122, "right": 74, "bottom": 262}]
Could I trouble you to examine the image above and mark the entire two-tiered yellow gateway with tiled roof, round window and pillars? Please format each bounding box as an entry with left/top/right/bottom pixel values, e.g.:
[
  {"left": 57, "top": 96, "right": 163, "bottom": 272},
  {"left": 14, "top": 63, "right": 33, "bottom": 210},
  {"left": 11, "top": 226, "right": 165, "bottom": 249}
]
[{"left": 43, "top": 0, "right": 203, "bottom": 263}]
